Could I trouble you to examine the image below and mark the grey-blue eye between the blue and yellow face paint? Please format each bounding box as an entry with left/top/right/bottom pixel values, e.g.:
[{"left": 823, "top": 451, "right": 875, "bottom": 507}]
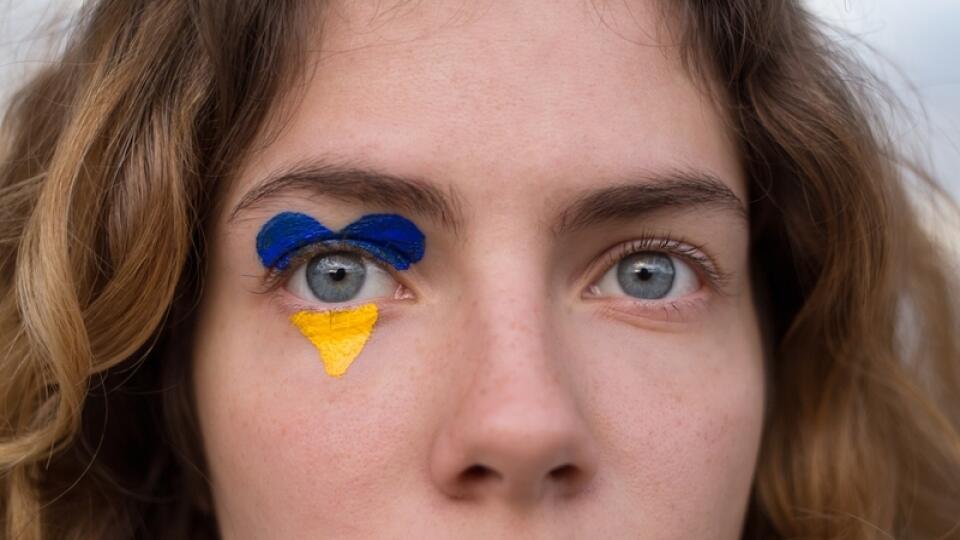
[{"left": 286, "top": 252, "right": 399, "bottom": 304}]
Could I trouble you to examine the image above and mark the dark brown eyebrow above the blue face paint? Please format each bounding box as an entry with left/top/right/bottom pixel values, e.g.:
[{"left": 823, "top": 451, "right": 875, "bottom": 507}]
[{"left": 229, "top": 160, "right": 463, "bottom": 232}]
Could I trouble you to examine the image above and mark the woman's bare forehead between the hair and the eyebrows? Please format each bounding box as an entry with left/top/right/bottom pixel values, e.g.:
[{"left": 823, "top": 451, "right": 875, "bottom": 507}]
[{"left": 232, "top": 0, "right": 745, "bottom": 211}]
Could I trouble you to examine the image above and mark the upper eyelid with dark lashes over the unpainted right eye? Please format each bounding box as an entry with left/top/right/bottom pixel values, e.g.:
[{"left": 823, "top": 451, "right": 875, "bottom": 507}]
[{"left": 587, "top": 234, "right": 733, "bottom": 293}]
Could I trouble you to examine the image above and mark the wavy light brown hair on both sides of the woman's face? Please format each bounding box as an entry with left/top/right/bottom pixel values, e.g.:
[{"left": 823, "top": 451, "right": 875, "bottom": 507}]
[{"left": 0, "top": 0, "right": 960, "bottom": 539}]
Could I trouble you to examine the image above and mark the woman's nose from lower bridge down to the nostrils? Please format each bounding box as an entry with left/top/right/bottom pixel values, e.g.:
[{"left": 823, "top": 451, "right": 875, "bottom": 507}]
[{"left": 430, "top": 292, "right": 597, "bottom": 506}]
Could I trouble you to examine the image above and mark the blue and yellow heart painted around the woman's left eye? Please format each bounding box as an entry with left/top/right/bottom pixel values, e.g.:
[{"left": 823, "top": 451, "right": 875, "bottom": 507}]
[{"left": 257, "top": 212, "right": 425, "bottom": 377}]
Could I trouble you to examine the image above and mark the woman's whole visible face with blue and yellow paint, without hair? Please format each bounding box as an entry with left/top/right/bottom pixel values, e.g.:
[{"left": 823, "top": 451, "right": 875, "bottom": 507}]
[{"left": 194, "top": 1, "right": 764, "bottom": 539}]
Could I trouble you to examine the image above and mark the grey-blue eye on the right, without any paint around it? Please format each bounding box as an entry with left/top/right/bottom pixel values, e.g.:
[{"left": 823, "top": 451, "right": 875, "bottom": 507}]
[{"left": 591, "top": 251, "right": 700, "bottom": 300}]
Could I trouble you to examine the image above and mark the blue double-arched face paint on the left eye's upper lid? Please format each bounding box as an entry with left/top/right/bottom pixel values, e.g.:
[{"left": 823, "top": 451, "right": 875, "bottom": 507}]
[{"left": 257, "top": 212, "right": 424, "bottom": 270}]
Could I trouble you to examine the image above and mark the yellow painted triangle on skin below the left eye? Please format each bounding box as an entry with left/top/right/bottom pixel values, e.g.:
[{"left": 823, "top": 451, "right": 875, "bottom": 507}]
[{"left": 290, "top": 304, "right": 378, "bottom": 377}]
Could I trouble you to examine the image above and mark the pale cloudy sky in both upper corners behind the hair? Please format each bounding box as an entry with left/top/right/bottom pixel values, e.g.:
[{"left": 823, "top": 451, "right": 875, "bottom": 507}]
[{"left": 0, "top": 0, "right": 960, "bottom": 198}]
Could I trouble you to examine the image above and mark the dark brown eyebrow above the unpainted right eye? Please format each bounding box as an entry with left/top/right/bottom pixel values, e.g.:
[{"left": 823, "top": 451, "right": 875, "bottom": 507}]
[{"left": 555, "top": 170, "right": 748, "bottom": 234}]
